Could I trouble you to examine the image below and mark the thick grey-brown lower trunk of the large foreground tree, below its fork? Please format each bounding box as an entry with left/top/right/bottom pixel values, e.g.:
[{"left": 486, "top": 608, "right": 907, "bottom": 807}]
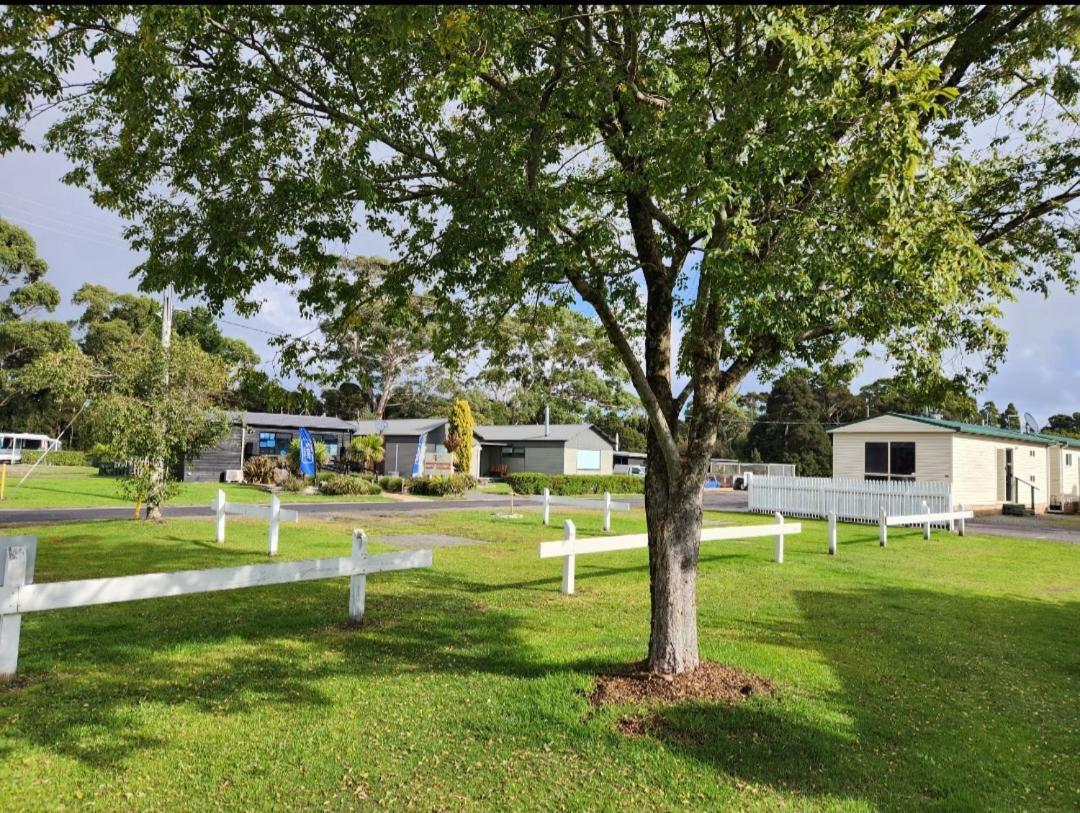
[{"left": 645, "top": 457, "right": 701, "bottom": 675}]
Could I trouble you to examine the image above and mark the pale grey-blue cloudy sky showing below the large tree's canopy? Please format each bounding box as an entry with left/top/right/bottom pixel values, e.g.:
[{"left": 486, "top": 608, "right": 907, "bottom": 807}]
[{"left": 0, "top": 138, "right": 1080, "bottom": 422}]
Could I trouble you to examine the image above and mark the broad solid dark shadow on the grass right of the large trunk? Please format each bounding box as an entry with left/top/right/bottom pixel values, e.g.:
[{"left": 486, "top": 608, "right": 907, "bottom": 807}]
[{"left": 639, "top": 588, "right": 1080, "bottom": 811}]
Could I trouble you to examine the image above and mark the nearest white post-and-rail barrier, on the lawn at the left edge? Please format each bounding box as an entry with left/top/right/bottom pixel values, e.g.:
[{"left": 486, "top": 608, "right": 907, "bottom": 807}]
[{"left": 0, "top": 530, "right": 431, "bottom": 678}]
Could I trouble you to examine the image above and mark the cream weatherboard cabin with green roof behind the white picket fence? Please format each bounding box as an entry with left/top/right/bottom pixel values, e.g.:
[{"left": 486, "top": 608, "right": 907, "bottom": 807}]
[{"left": 829, "top": 412, "right": 1080, "bottom": 512}]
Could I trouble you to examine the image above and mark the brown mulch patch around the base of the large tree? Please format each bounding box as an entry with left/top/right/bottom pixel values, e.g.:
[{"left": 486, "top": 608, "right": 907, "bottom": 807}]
[{"left": 589, "top": 661, "right": 775, "bottom": 708}]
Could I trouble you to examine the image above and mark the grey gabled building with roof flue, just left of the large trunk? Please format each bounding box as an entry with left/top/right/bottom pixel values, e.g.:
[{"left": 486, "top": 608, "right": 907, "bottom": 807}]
[{"left": 476, "top": 423, "right": 615, "bottom": 477}]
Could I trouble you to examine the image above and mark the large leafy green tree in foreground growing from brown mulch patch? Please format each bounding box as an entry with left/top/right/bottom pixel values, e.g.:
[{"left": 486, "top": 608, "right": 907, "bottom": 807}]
[{"left": 0, "top": 5, "right": 1080, "bottom": 673}]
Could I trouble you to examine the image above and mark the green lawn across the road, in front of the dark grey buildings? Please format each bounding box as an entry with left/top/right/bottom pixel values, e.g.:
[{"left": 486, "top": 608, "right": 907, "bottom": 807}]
[{"left": 0, "top": 466, "right": 388, "bottom": 509}]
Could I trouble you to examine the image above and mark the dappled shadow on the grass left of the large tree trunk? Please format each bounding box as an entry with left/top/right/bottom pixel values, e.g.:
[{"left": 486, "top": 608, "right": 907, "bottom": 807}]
[{"left": 0, "top": 571, "right": 591, "bottom": 768}]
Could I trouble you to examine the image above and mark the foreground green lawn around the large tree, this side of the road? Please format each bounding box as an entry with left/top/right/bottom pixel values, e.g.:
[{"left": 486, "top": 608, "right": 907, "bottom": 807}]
[{"left": 0, "top": 511, "right": 1080, "bottom": 811}]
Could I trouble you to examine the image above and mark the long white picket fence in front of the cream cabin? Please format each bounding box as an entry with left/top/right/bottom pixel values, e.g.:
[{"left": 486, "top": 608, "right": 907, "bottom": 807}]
[{"left": 747, "top": 476, "right": 953, "bottom": 523}]
